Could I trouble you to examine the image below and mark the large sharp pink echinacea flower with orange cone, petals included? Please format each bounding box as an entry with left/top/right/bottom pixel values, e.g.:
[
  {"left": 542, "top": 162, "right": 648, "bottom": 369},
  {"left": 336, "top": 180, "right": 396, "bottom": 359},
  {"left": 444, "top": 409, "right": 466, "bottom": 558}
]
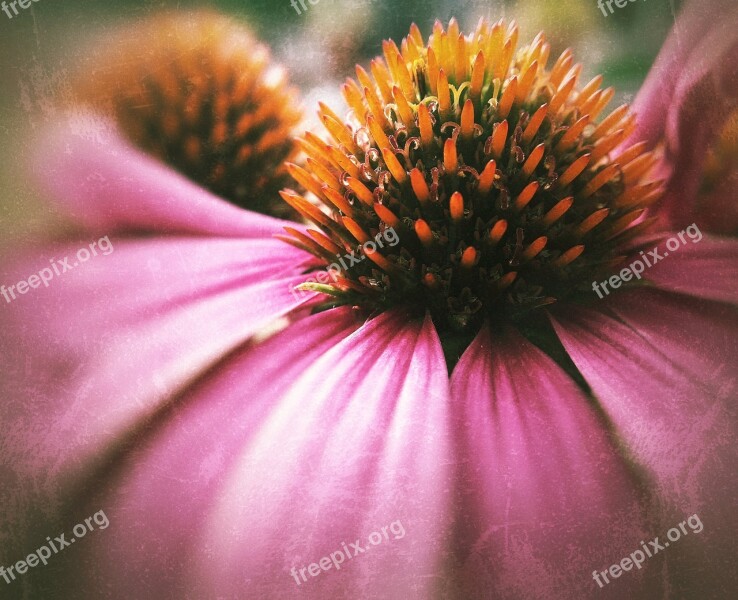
[{"left": 4, "top": 3, "right": 738, "bottom": 599}]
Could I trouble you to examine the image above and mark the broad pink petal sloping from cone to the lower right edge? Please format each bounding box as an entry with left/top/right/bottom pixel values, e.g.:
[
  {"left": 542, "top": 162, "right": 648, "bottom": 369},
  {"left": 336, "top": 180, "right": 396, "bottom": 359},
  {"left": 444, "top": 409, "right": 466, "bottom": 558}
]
[{"left": 553, "top": 290, "right": 738, "bottom": 597}]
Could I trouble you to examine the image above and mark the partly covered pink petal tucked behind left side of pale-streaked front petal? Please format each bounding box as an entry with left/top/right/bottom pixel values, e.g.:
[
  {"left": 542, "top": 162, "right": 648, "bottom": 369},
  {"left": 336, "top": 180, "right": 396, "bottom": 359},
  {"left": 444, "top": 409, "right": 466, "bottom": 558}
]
[{"left": 2, "top": 309, "right": 360, "bottom": 598}]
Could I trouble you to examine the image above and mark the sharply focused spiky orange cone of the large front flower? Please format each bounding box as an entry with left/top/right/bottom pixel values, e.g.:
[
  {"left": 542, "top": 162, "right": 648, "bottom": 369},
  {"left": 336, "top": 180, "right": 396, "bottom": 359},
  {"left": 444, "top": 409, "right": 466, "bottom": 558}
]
[{"left": 283, "top": 20, "right": 661, "bottom": 332}]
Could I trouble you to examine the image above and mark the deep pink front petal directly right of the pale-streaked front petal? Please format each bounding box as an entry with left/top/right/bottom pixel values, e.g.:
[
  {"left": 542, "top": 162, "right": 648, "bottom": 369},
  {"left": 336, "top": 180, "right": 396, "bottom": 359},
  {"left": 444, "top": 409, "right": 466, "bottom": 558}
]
[{"left": 451, "top": 330, "right": 659, "bottom": 599}]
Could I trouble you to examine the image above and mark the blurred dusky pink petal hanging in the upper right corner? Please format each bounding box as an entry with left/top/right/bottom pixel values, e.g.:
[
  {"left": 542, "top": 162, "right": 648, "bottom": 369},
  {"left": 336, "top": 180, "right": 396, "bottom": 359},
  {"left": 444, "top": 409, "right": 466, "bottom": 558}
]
[{"left": 631, "top": 0, "right": 738, "bottom": 230}]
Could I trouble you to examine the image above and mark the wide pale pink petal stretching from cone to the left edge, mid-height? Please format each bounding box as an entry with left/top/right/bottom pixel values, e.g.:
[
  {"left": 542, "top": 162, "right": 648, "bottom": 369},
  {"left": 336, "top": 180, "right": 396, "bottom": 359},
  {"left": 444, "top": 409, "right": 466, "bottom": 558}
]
[{"left": 2, "top": 238, "right": 316, "bottom": 486}]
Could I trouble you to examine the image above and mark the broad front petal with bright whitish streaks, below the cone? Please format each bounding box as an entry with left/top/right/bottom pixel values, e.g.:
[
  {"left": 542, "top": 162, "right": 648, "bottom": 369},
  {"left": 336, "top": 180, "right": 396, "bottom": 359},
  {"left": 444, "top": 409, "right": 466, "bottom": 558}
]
[{"left": 194, "top": 313, "right": 450, "bottom": 598}]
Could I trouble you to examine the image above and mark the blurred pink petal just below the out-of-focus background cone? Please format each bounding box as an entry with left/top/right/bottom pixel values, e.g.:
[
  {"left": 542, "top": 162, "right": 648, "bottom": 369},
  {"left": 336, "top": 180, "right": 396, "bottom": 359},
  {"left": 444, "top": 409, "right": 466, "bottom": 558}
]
[{"left": 33, "top": 117, "right": 291, "bottom": 237}]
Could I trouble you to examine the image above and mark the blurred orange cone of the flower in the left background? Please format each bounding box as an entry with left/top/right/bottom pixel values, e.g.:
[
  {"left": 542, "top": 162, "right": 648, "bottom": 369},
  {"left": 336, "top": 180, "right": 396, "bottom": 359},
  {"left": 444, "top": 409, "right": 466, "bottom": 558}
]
[{"left": 78, "top": 11, "right": 301, "bottom": 215}]
